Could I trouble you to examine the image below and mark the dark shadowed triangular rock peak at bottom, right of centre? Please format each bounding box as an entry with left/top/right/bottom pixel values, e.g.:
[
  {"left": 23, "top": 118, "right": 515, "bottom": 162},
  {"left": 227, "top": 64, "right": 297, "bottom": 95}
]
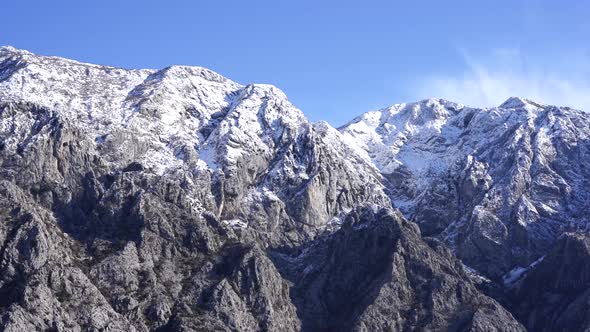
[{"left": 278, "top": 208, "right": 524, "bottom": 331}]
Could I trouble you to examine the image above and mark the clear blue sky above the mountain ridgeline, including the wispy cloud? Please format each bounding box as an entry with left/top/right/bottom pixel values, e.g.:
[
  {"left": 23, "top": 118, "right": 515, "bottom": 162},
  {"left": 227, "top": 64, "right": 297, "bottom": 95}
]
[{"left": 0, "top": 0, "right": 590, "bottom": 126}]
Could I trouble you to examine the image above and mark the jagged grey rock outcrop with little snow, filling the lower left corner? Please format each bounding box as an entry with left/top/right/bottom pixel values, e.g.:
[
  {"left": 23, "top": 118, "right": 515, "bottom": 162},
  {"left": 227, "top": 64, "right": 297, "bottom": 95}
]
[{"left": 0, "top": 169, "right": 298, "bottom": 331}]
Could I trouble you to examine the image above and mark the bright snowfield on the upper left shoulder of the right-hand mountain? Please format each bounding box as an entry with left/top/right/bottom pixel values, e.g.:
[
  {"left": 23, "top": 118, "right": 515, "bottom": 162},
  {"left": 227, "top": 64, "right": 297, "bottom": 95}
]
[{"left": 340, "top": 99, "right": 463, "bottom": 193}]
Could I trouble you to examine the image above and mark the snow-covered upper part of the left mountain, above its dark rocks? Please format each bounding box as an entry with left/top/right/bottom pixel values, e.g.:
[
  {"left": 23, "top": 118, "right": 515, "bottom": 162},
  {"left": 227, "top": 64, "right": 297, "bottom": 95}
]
[{"left": 0, "top": 47, "right": 389, "bottom": 246}]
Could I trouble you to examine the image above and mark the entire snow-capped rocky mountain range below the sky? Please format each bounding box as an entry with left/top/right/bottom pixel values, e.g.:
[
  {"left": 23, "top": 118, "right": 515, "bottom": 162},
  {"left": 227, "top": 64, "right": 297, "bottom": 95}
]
[{"left": 0, "top": 47, "right": 590, "bottom": 331}]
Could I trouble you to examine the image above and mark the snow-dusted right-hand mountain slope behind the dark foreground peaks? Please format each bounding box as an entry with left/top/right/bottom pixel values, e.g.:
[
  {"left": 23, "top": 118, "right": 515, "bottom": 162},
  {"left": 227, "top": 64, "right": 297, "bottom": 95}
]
[{"left": 340, "top": 98, "right": 590, "bottom": 280}]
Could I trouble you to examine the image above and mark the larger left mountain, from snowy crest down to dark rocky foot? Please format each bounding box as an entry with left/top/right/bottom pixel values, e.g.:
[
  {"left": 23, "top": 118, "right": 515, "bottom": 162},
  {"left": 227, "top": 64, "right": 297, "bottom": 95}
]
[{"left": 5, "top": 48, "right": 523, "bottom": 331}]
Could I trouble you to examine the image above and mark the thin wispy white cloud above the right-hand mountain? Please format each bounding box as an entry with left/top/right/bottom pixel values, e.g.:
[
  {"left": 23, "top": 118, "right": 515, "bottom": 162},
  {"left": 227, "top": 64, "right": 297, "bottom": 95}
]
[{"left": 420, "top": 49, "right": 590, "bottom": 111}]
